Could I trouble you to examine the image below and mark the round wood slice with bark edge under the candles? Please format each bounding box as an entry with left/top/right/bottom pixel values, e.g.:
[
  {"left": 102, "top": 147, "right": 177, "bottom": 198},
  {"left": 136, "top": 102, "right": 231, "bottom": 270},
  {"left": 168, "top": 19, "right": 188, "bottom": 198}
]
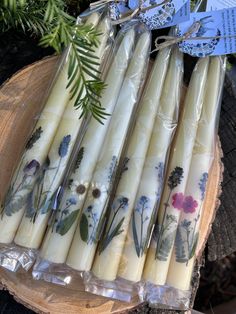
[{"left": 0, "top": 57, "right": 223, "bottom": 314}]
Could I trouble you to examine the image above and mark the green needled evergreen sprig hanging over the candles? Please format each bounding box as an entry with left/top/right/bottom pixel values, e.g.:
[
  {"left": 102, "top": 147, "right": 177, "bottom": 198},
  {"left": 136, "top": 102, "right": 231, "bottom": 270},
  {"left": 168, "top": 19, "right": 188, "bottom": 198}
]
[{"left": 0, "top": 0, "right": 107, "bottom": 123}]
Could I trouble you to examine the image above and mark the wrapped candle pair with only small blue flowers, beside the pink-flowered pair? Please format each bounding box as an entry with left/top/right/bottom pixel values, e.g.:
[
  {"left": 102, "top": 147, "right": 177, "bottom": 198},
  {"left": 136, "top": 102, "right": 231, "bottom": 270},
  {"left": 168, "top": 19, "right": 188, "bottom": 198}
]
[{"left": 85, "top": 47, "right": 183, "bottom": 301}]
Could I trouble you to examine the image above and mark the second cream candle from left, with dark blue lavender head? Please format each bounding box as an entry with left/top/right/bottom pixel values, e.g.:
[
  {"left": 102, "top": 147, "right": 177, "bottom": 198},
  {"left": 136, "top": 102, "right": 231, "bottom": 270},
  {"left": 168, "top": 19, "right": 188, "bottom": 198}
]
[{"left": 14, "top": 18, "right": 111, "bottom": 249}]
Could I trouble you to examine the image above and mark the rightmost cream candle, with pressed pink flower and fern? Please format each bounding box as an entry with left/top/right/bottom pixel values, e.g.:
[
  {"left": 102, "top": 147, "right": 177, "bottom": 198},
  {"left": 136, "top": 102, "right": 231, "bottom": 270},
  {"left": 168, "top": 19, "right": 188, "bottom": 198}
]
[{"left": 166, "top": 57, "right": 223, "bottom": 290}]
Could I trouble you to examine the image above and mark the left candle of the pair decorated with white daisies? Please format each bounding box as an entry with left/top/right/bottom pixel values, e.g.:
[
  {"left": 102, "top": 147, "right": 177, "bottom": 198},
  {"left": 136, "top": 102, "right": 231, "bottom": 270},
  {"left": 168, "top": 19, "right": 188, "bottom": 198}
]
[{"left": 40, "top": 29, "right": 135, "bottom": 263}]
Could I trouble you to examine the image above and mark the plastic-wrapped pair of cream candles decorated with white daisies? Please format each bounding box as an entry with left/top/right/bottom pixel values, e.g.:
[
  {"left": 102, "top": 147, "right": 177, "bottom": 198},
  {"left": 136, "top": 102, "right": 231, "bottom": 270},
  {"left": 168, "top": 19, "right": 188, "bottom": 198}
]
[{"left": 33, "top": 22, "right": 150, "bottom": 281}]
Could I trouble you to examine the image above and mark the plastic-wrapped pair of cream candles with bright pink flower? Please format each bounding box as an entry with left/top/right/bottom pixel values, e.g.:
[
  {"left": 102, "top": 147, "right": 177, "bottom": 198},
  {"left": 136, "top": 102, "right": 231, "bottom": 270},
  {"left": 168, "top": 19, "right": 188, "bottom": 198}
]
[{"left": 140, "top": 57, "right": 225, "bottom": 310}]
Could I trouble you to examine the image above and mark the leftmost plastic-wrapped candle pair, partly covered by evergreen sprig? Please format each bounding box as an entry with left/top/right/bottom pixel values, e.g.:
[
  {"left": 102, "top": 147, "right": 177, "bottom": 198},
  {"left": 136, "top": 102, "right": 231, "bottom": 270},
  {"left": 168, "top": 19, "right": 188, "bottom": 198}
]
[{"left": 0, "top": 13, "right": 113, "bottom": 271}]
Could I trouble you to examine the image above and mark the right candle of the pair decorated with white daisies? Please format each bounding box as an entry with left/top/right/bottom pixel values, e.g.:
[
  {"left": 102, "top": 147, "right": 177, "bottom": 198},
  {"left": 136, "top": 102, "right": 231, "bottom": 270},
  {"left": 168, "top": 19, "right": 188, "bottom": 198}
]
[{"left": 66, "top": 33, "right": 150, "bottom": 270}]
